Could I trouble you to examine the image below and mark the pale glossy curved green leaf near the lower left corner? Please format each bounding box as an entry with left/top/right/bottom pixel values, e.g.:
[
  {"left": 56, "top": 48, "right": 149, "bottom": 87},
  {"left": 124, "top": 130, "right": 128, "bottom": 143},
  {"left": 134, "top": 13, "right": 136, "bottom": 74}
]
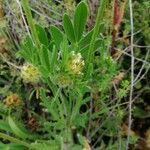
[{"left": 8, "top": 116, "right": 28, "bottom": 139}]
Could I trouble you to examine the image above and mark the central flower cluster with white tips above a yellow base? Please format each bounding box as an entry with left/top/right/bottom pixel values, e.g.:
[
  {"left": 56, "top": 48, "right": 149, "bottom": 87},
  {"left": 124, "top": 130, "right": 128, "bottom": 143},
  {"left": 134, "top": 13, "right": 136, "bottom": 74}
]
[{"left": 68, "top": 51, "right": 85, "bottom": 75}]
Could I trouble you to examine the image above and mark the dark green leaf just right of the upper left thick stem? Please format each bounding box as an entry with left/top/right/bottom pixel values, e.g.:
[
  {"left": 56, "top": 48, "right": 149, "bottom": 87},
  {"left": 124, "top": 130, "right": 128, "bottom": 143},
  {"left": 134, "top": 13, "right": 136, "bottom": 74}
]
[{"left": 35, "top": 24, "right": 48, "bottom": 46}]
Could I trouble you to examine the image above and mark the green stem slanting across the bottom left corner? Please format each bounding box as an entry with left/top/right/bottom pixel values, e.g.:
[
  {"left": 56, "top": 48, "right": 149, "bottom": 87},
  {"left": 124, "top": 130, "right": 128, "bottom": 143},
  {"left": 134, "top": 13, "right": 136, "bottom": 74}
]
[{"left": 0, "top": 132, "right": 31, "bottom": 148}]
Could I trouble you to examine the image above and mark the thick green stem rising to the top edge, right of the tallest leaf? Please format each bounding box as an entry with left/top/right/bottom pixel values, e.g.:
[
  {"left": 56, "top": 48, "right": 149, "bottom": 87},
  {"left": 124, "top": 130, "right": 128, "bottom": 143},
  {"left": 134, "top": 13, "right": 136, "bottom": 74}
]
[{"left": 87, "top": 0, "right": 107, "bottom": 65}]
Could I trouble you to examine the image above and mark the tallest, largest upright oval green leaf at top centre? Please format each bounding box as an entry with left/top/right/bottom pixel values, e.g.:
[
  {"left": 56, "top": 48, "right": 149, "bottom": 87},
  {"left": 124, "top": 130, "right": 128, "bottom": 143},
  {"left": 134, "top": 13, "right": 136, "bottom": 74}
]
[{"left": 74, "top": 2, "right": 88, "bottom": 41}]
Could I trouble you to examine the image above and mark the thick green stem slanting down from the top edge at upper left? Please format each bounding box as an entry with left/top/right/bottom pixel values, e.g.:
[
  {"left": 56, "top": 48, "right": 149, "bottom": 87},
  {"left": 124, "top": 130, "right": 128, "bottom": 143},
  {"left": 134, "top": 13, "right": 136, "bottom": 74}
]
[{"left": 21, "top": 0, "right": 40, "bottom": 48}]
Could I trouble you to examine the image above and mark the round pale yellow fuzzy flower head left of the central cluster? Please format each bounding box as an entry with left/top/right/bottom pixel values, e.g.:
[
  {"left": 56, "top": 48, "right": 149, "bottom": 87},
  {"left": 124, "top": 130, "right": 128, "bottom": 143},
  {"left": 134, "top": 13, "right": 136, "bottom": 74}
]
[{"left": 21, "top": 64, "right": 40, "bottom": 83}]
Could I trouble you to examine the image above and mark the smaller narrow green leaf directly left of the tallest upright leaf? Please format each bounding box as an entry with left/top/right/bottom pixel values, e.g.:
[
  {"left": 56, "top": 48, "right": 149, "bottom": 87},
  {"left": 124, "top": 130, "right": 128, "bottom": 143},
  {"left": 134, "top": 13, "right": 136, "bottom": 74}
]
[{"left": 63, "top": 14, "right": 76, "bottom": 43}]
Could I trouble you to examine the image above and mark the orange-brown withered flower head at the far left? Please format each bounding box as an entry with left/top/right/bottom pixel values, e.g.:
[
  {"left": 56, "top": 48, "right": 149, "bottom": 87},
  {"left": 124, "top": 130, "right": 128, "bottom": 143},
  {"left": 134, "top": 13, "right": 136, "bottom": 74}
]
[{"left": 4, "top": 93, "right": 21, "bottom": 107}]
